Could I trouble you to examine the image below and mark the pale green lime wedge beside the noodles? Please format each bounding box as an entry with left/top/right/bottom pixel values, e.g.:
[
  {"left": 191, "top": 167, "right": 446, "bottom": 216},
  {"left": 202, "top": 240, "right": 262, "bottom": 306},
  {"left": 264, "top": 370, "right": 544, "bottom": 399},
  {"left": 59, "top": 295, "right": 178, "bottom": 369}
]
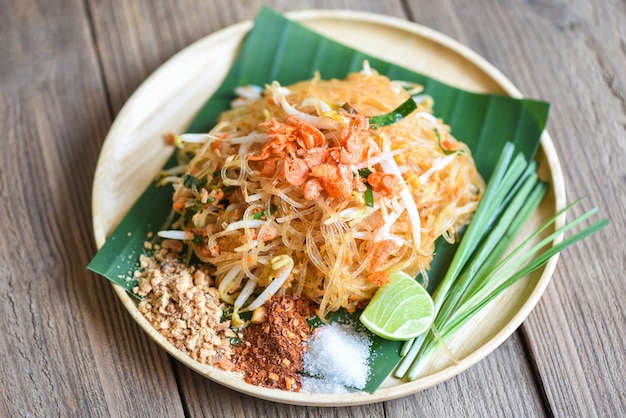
[{"left": 359, "top": 271, "right": 435, "bottom": 340}]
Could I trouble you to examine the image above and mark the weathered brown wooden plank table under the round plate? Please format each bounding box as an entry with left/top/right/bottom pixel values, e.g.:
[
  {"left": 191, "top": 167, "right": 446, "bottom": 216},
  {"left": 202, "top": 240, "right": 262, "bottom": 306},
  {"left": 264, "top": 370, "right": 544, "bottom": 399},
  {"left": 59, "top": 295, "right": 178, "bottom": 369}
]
[{"left": 0, "top": 0, "right": 626, "bottom": 417}]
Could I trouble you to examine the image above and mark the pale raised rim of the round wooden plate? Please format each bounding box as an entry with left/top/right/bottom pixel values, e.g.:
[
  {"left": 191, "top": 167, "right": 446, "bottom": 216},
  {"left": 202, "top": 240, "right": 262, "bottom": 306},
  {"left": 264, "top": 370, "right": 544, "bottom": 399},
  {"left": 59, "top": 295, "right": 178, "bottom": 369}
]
[{"left": 92, "top": 9, "right": 566, "bottom": 406}]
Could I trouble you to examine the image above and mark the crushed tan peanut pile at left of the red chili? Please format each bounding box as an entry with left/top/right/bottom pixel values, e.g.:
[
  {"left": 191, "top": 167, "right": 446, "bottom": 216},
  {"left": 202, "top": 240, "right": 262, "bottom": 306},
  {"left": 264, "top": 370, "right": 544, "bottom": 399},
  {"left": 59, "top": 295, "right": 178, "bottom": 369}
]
[{"left": 134, "top": 241, "right": 236, "bottom": 370}]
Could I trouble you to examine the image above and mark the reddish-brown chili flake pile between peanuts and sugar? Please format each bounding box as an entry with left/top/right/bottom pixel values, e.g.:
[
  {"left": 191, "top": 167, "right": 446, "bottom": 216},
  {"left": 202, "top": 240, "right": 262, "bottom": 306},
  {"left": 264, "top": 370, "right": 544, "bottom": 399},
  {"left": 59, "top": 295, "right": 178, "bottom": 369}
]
[{"left": 234, "top": 296, "right": 314, "bottom": 391}]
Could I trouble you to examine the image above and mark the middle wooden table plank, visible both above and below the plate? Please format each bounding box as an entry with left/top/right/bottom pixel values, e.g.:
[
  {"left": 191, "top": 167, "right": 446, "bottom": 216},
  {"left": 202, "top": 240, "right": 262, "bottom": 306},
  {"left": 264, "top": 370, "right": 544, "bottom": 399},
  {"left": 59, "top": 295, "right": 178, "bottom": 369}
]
[{"left": 83, "top": 0, "right": 541, "bottom": 416}]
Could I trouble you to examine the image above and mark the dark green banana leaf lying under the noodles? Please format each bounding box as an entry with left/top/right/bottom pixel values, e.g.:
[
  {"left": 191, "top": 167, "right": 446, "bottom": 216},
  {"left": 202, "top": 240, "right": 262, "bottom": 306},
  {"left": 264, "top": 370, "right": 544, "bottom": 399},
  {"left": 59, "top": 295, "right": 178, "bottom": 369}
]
[{"left": 88, "top": 8, "right": 549, "bottom": 392}]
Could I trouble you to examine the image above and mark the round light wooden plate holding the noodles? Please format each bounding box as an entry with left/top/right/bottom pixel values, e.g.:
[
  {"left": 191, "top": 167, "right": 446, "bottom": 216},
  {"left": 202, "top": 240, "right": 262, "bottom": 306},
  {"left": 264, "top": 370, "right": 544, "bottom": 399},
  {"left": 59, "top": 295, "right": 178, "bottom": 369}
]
[{"left": 93, "top": 11, "right": 565, "bottom": 406}]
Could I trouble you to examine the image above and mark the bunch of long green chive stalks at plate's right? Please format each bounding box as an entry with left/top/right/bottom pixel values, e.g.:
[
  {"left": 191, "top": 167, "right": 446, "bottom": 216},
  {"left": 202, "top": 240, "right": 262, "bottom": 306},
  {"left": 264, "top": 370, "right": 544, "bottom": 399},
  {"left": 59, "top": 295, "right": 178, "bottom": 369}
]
[{"left": 395, "top": 143, "right": 608, "bottom": 380}]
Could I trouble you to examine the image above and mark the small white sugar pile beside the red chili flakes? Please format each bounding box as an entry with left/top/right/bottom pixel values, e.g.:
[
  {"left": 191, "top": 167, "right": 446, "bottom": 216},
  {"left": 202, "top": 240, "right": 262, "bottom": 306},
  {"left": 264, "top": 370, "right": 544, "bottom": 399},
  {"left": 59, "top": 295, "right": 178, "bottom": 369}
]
[{"left": 302, "top": 323, "right": 371, "bottom": 393}]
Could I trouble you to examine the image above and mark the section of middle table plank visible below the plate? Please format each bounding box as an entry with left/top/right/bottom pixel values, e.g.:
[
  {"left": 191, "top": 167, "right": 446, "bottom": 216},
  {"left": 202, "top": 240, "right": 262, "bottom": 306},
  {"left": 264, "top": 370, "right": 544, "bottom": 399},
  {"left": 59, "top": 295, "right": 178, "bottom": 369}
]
[{"left": 177, "top": 335, "right": 544, "bottom": 417}]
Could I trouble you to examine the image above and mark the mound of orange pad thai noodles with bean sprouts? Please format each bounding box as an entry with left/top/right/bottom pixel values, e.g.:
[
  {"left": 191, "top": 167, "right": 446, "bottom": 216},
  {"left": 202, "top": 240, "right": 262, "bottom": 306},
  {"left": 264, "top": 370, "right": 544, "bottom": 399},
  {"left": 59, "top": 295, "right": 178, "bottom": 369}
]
[{"left": 160, "top": 63, "right": 484, "bottom": 320}]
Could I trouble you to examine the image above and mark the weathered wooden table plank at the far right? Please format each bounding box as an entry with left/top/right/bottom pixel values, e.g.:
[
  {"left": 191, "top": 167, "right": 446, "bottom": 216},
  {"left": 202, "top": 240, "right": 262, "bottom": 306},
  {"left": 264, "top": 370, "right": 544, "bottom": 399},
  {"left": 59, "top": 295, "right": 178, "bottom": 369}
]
[{"left": 402, "top": 1, "right": 626, "bottom": 416}]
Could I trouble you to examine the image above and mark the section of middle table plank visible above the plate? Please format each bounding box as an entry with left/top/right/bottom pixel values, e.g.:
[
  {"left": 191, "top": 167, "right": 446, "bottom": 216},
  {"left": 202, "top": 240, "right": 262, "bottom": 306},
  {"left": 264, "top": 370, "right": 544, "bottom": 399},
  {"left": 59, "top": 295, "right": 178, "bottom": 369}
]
[{"left": 89, "top": 0, "right": 403, "bottom": 113}]
